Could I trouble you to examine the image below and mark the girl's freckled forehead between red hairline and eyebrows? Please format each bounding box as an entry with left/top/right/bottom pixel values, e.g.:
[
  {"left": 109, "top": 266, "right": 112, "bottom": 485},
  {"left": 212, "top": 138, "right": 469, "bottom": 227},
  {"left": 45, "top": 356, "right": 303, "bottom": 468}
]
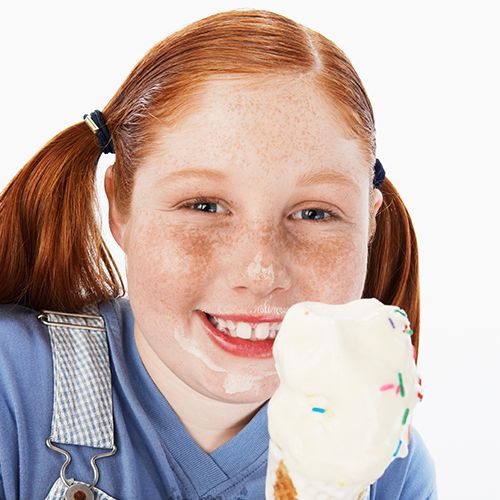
[{"left": 143, "top": 76, "right": 371, "bottom": 187}]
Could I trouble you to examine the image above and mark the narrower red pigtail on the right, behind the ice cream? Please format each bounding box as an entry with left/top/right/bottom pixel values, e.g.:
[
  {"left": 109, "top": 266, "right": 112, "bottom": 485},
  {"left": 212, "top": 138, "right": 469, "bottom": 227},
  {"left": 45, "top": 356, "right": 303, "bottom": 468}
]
[{"left": 363, "top": 178, "right": 420, "bottom": 354}]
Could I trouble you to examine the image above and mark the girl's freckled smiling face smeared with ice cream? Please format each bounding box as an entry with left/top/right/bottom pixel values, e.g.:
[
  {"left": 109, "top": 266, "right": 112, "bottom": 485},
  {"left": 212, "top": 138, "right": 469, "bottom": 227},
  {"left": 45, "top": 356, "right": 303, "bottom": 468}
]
[{"left": 112, "top": 78, "right": 381, "bottom": 403}]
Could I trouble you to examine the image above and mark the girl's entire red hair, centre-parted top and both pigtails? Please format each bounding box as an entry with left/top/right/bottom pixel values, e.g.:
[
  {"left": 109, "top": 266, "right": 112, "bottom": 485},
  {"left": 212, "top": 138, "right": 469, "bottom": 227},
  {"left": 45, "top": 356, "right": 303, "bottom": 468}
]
[{"left": 0, "top": 10, "right": 419, "bottom": 356}]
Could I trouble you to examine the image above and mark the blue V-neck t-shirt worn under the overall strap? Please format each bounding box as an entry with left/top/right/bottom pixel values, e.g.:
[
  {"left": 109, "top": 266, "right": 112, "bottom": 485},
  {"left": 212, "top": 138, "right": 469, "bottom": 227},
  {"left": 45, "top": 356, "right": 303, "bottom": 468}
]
[{"left": 0, "top": 299, "right": 437, "bottom": 500}]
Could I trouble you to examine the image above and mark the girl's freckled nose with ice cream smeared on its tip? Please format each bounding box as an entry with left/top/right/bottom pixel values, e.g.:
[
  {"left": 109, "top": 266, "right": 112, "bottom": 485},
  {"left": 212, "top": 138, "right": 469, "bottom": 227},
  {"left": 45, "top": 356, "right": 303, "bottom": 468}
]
[{"left": 227, "top": 229, "right": 291, "bottom": 297}]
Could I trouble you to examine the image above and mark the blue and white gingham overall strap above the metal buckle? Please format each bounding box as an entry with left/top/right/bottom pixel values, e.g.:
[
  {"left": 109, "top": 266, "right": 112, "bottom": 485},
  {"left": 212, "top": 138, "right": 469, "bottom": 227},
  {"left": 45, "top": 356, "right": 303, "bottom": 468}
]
[{"left": 43, "top": 307, "right": 114, "bottom": 448}]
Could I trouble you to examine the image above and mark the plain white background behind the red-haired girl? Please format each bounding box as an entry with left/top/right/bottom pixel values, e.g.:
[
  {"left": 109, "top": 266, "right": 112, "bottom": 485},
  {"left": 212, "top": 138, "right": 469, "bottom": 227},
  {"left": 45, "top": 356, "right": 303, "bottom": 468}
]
[{"left": 0, "top": 0, "right": 500, "bottom": 500}]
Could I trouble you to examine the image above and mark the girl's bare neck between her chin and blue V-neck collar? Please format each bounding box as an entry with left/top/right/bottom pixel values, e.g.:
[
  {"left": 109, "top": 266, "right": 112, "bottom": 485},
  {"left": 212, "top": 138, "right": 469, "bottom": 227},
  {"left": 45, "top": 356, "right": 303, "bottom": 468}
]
[{"left": 136, "top": 328, "right": 264, "bottom": 453}]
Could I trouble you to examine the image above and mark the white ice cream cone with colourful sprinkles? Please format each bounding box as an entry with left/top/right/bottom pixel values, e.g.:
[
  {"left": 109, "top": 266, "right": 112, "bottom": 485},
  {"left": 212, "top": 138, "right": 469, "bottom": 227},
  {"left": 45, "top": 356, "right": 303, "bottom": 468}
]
[{"left": 266, "top": 299, "right": 422, "bottom": 500}]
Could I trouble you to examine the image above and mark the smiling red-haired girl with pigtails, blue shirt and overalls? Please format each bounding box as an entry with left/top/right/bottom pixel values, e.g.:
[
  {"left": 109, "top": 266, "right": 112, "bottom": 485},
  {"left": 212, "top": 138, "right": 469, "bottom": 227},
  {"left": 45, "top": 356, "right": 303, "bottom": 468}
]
[{"left": 0, "top": 11, "right": 435, "bottom": 500}]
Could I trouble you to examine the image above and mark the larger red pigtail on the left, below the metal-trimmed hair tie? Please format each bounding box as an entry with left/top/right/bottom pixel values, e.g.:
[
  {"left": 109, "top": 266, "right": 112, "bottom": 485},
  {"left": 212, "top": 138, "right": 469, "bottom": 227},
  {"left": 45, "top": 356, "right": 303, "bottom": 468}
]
[{"left": 0, "top": 122, "right": 123, "bottom": 312}]
